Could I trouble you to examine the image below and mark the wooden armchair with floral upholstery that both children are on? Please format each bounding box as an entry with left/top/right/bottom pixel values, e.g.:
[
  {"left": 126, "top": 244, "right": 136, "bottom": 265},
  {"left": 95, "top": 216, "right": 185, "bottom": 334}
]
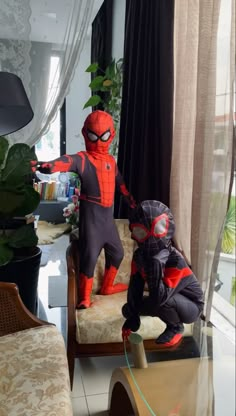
[{"left": 67, "top": 219, "right": 192, "bottom": 385}]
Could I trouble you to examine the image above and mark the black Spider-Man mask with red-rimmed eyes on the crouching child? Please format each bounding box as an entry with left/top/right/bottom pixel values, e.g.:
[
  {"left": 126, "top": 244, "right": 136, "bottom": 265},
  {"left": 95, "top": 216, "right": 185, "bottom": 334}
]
[{"left": 129, "top": 200, "right": 175, "bottom": 256}]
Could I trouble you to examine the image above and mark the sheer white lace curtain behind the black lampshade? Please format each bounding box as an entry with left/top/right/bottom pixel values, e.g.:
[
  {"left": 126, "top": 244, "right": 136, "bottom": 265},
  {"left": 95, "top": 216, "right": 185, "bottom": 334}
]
[{"left": 0, "top": 0, "right": 94, "bottom": 146}]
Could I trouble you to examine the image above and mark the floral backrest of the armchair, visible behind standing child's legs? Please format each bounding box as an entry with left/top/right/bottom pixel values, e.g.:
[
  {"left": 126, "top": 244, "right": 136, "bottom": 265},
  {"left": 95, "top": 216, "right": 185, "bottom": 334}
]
[{"left": 93, "top": 219, "right": 136, "bottom": 293}]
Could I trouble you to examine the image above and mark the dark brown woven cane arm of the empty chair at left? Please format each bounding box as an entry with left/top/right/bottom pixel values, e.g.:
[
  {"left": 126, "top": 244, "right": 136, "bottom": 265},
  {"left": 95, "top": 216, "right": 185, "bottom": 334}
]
[{"left": 0, "top": 282, "right": 53, "bottom": 336}]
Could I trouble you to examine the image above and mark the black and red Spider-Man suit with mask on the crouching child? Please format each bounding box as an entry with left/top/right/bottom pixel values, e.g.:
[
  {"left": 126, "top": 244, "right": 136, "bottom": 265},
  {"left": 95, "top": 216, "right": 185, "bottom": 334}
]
[{"left": 122, "top": 200, "right": 204, "bottom": 346}]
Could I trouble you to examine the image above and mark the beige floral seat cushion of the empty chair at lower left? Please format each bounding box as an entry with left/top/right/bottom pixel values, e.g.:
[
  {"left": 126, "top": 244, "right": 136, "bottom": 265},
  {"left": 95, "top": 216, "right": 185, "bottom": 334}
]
[{"left": 0, "top": 325, "right": 73, "bottom": 416}]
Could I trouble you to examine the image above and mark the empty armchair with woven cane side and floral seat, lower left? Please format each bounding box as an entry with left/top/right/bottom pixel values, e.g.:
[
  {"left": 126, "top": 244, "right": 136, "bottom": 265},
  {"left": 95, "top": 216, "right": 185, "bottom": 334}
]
[{"left": 0, "top": 282, "right": 73, "bottom": 416}]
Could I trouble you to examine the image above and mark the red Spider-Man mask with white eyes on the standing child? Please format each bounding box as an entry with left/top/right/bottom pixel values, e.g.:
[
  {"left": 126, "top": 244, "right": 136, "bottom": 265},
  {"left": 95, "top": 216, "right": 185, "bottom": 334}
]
[{"left": 82, "top": 110, "right": 116, "bottom": 153}]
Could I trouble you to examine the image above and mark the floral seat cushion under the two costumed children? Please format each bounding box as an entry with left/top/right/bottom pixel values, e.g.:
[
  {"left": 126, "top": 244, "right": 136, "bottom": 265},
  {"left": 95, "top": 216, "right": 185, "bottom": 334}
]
[{"left": 76, "top": 292, "right": 192, "bottom": 344}]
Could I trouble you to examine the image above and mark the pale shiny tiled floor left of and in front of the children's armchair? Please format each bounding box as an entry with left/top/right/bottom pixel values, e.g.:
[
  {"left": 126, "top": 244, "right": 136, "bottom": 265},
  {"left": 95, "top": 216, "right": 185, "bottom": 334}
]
[{"left": 39, "top": 235, "right": 126, "bottom": 416}]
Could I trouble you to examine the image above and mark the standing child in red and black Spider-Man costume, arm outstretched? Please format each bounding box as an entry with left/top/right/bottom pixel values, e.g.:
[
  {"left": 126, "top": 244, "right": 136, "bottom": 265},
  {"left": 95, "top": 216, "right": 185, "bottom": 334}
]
[{"left": 33, "top": 110, "right": 135, "bottom": 309}]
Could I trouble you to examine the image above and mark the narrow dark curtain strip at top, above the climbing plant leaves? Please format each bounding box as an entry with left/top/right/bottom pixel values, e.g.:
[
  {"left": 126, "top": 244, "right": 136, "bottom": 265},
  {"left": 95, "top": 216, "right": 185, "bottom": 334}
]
[{"left": 91, "top": 0, "right": 113, "bottom": 110}]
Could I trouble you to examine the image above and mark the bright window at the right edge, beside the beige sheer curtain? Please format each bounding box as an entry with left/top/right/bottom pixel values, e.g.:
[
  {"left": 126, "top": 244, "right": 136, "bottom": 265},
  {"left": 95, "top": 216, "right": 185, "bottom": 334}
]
[{"left": 211, "top": 0, "right": 236, "bottom": 336}]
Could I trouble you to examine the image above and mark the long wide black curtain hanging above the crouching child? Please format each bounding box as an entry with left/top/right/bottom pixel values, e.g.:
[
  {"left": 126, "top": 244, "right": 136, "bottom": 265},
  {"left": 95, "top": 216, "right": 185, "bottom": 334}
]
[{"left": 115, "top": 0, "right": 174, "bottom": 218}]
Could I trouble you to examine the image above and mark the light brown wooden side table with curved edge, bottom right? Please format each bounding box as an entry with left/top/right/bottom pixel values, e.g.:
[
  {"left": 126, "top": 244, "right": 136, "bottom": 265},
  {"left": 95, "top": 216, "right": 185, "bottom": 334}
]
[{"left": 109, "top": 357, "right": 214, "bottom": 416}]
